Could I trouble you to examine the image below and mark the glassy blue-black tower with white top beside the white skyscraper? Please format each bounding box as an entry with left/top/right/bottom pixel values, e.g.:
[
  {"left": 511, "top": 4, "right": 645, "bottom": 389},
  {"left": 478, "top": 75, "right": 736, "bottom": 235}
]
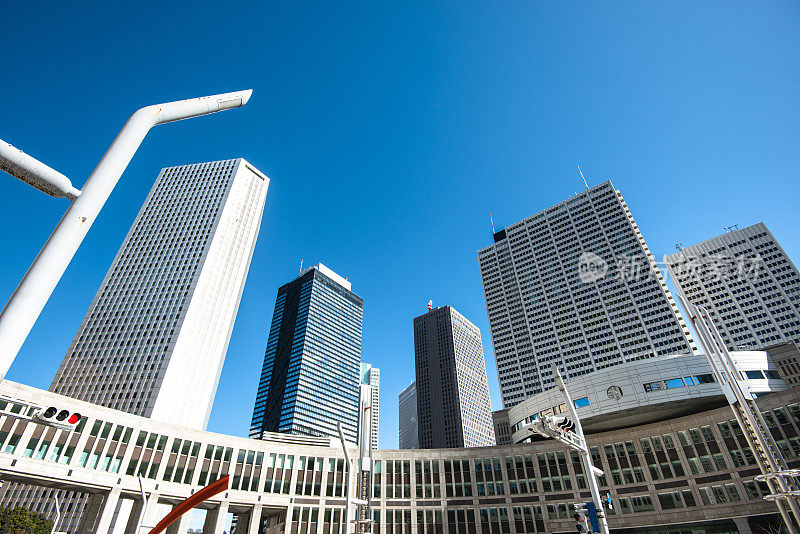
[{"left": 250, "top": 264, "right": 364, "bottom": 443}]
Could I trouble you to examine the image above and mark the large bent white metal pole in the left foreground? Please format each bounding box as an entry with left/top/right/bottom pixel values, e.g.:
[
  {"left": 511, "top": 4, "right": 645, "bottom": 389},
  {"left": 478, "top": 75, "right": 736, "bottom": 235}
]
[{"left": 0, "top": 90, "right": 252, "bottom": 380}]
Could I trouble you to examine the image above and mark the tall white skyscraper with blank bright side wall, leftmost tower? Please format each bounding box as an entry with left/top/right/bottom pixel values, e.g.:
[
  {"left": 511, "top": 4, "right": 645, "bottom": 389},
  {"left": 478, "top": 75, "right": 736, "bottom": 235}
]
[{"left": 50, "top": 159, "right": 269, "bottom": 429}]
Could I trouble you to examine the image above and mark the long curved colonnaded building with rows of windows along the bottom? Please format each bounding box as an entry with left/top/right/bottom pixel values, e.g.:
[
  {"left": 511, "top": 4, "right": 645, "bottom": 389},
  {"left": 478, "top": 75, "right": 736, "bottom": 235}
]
[{"left": 0, "top": 380, "right": 800, "bottom": 534}]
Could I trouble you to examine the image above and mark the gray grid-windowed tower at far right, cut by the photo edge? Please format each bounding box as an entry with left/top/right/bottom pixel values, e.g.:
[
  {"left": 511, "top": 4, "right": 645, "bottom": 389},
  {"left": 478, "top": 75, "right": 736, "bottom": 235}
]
[{"left": 665, "top": 223, "right": 800, "bottom": 350}]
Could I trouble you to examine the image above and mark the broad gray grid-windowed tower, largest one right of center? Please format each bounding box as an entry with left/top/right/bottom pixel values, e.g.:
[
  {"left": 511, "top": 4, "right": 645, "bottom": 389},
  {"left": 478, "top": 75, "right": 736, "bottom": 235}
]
[{"left": 478, "top": 181, "right": 696, "bottom": 408}]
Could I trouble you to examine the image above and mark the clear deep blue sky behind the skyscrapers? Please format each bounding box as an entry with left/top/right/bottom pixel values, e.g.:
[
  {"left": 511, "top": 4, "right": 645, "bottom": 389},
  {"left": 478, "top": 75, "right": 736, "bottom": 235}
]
[{"left": 0, "top": 1, "right": 800, "bottom": 448}]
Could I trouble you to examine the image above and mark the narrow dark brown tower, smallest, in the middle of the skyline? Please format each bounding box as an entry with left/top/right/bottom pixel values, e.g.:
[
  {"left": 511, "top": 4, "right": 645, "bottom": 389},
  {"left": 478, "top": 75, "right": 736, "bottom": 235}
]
[{"left": 414, "top": 306, "right": 495, "bottom": 449}]
